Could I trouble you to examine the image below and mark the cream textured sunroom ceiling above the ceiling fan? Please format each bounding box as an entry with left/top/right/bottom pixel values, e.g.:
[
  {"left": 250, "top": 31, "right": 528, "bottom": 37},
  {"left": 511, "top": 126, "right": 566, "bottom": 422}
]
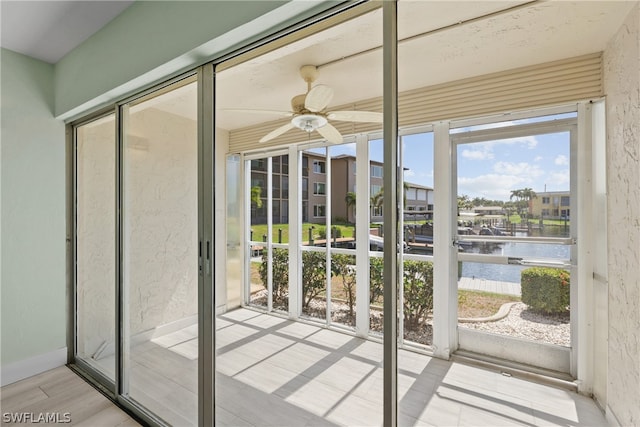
[{"left": 217, "top": 0, "right": 633, "bottom": 131}]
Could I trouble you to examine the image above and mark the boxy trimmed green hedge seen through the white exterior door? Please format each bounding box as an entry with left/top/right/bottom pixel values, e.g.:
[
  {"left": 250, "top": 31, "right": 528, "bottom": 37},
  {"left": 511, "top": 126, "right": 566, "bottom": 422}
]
[{"left": 521, "top": 267, "right": 570, "bottom": 314}]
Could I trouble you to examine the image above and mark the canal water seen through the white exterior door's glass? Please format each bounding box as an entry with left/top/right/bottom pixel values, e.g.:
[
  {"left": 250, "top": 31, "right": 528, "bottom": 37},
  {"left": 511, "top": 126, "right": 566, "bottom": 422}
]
[{"left": 462, "top": 226, "right": 571, "bottom": 283}]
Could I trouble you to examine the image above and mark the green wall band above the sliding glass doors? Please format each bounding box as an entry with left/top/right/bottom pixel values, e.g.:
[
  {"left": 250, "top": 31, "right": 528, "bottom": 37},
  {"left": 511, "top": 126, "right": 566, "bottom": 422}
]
[{"left": 54, "top": 0, "right": 340, "bottom": 119}]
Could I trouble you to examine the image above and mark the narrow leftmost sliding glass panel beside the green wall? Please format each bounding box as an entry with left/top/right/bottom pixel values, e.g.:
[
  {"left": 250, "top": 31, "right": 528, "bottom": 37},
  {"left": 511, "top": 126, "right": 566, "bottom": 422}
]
[{"left": 75, "top": 114, "right": 116, "bottom": 381}]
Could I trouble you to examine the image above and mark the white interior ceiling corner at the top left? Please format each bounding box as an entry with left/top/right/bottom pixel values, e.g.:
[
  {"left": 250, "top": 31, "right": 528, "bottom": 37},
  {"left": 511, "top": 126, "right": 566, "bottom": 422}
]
[{"left": 0, "top": 0, "right": 133, "bottom": 64}]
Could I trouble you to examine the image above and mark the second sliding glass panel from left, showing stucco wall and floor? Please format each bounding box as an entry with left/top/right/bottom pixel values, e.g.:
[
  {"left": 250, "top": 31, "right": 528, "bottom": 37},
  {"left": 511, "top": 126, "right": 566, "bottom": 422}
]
[{"left": 122, "top": 79, "right": 199, "bottom": 425}]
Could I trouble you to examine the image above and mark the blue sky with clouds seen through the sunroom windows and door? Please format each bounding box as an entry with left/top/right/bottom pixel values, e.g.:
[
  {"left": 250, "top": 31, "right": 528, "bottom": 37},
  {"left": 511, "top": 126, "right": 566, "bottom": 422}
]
[{"left": 322, "top": 116, "right": 570, "bottom": 201}]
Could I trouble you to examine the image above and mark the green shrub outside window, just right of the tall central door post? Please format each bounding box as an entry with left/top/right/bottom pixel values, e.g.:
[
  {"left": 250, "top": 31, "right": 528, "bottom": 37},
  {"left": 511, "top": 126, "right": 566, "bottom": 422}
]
[{"left": 402, "top": 261, "right": 433, "bottom": 329}]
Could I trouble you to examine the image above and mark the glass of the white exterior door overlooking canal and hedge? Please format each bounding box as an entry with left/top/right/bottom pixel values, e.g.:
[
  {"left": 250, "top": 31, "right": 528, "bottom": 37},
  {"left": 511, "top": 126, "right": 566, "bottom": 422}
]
[{"left": 454, "top": 123, "right": 576, "bottom": 372}]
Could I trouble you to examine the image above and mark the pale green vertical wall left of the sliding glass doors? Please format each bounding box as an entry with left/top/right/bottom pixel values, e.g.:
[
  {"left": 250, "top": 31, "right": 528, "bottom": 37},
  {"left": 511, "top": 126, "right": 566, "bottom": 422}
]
[{"left": 0, "top": 49, "right": 66, "bottom": 367}]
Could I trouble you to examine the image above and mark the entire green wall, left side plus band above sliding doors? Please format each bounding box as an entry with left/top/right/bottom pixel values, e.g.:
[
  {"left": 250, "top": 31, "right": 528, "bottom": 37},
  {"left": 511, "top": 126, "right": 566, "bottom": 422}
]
[{"left": 0, "top": 0, "right": 340, "bottom": 367}]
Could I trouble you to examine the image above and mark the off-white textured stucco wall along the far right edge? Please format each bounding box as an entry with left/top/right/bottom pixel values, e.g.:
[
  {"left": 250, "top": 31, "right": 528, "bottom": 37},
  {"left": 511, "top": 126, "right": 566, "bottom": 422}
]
[{"left": 595, "top": 4, "right": 640, "bottom": 426}]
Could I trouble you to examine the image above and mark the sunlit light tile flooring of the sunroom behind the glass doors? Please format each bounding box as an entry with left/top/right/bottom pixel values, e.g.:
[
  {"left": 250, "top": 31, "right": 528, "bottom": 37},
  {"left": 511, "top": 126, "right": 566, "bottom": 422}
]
[{"left": 74, "top": 309, "right": 606, "bottom": 427}]
